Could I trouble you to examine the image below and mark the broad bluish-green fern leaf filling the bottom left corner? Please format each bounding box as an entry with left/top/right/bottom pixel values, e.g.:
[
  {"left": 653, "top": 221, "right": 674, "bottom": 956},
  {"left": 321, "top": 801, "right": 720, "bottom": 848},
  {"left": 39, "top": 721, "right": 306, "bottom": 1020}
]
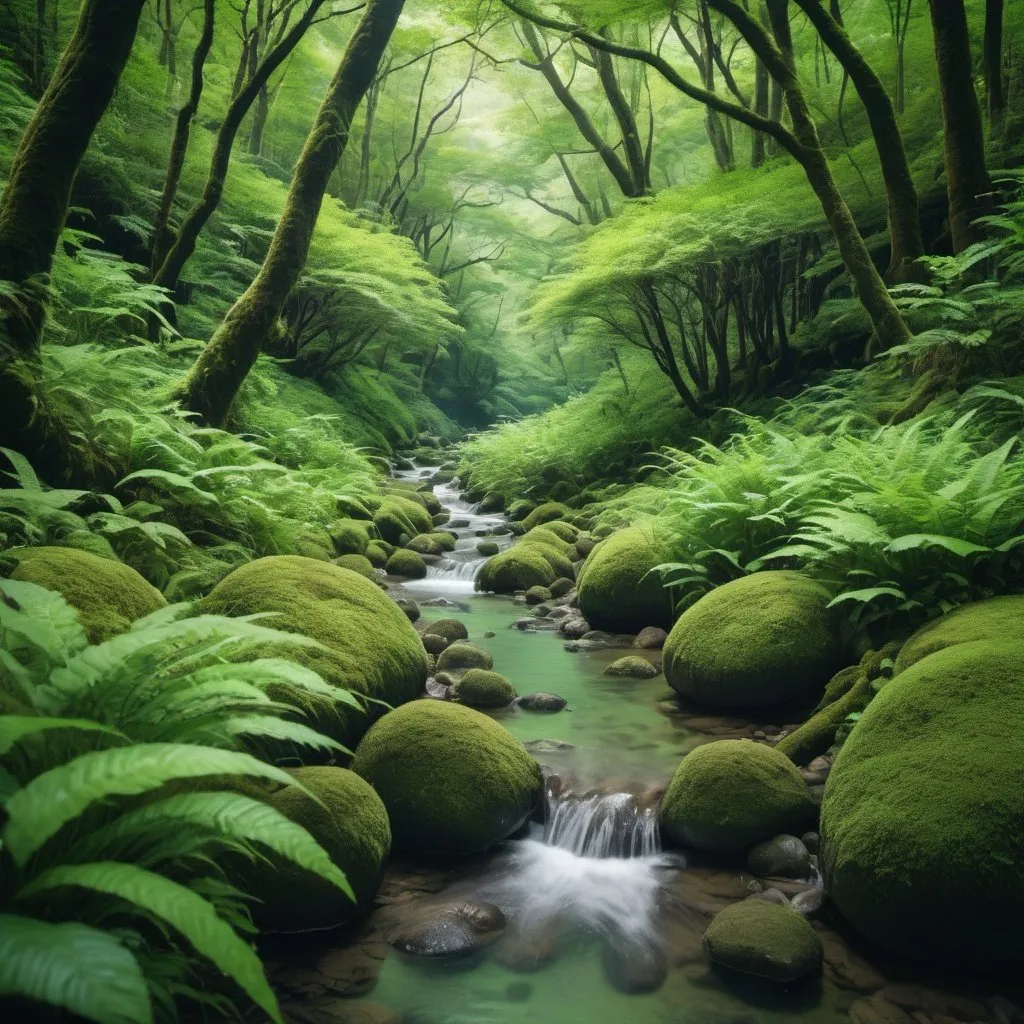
[{"left": 0, "top": 914, "right": 153, "bottom": 1024}]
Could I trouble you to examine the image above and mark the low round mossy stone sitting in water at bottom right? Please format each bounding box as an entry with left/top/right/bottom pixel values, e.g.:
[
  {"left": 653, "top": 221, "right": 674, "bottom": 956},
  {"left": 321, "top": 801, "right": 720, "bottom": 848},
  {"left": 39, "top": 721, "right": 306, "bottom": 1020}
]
[{"left": 703, "top": 899, "right": 823, "bottom": 983}]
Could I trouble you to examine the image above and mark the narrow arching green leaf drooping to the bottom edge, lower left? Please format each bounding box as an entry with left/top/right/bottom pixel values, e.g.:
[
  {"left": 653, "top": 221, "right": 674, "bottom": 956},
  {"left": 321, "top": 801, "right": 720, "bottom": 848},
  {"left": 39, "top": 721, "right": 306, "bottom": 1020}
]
[{"left": 16, "top": 860, "right": 282, "bottom": 1024}]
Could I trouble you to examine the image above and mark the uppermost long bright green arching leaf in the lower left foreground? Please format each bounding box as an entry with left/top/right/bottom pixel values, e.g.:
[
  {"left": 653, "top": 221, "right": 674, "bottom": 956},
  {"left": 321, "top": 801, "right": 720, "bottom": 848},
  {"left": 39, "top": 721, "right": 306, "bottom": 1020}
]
[{"left": 2, "top": 743, "right": 301, "bottom": 865}]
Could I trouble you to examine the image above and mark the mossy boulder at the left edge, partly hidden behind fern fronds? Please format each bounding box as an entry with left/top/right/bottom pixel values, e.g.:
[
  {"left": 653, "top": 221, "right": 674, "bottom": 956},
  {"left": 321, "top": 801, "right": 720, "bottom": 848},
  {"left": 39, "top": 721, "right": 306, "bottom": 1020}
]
[{"left": 5, "top": 547, "right": 167, "bottom": 643}]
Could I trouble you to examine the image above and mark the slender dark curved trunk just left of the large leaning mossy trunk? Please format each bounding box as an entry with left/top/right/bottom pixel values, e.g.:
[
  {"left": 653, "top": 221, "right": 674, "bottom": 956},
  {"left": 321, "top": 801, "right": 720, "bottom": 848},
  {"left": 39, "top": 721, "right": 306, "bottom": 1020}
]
[{"left": 153, "top": 0, "right": 324, "bottom": 292}]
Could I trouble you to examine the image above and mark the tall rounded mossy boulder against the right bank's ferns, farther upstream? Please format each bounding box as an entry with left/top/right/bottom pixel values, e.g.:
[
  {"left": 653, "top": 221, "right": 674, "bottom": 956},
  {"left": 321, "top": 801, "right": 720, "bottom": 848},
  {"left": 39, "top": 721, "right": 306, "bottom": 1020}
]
[{"left": 577, "top": 526, "right": 673, "bottom": 633}]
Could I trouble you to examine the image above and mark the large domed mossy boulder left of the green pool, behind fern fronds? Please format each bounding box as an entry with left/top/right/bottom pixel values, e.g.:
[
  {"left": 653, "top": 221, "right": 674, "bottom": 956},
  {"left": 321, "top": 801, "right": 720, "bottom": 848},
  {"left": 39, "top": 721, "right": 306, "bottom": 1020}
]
[{"left": 199, "top": 555, "right": 429, "bottom": 745}]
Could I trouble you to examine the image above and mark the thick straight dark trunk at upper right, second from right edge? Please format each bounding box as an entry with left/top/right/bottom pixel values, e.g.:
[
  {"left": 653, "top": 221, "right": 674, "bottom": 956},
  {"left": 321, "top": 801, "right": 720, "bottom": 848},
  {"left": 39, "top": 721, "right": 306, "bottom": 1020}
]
[{"left": 928, "top": 0, "right": 991, "bottom": 253}]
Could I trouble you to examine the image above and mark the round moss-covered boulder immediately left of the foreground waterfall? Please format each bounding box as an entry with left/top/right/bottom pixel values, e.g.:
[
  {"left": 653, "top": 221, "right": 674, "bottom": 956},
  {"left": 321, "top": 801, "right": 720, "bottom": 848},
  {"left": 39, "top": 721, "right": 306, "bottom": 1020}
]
[{"left": 352, "top": 700, "right": 541, "bottom": 855}]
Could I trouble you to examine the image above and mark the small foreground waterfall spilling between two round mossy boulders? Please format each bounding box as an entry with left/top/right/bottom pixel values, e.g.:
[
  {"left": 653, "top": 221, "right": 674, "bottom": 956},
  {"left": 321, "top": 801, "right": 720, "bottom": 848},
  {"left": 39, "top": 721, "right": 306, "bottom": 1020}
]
[{"left": 544, "top": 793, "right": 660, "bottom": 858}]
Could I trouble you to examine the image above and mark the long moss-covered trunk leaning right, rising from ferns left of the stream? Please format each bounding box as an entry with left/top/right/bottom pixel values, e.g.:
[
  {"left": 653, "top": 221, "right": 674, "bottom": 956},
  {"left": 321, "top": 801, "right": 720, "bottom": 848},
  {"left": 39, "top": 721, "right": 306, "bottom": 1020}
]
[{"left": 179, "top": 0, "right": 404, "bottom": 423}]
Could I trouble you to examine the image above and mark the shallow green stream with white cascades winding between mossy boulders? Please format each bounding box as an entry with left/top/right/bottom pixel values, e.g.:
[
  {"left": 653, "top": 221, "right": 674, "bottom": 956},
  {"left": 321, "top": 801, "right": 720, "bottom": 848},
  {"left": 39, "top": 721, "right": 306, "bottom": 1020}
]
[{"left": 266, "top": 469, "right": 1015, "bottom": 1024}]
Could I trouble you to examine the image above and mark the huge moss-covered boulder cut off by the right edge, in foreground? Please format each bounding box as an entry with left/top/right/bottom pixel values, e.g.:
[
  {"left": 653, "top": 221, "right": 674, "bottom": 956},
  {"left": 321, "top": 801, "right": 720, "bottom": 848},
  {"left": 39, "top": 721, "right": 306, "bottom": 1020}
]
[{"left": 821, "top": 633, "right": 1024, "bottom": 969}]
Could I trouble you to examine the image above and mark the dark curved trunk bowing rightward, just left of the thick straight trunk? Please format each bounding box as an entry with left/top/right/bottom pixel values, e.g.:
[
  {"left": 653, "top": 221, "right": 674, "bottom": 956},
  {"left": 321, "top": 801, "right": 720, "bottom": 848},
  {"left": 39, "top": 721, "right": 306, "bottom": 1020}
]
[{"left": 797, "top": 0, "right": 925, "bottom": 283}]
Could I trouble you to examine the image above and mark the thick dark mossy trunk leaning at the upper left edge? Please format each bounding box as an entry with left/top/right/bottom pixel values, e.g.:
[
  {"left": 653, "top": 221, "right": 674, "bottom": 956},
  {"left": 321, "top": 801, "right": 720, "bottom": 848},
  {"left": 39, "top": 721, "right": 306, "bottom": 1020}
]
[{"left": 0, "top": 0, "right": 144, "bottom": 355}]
